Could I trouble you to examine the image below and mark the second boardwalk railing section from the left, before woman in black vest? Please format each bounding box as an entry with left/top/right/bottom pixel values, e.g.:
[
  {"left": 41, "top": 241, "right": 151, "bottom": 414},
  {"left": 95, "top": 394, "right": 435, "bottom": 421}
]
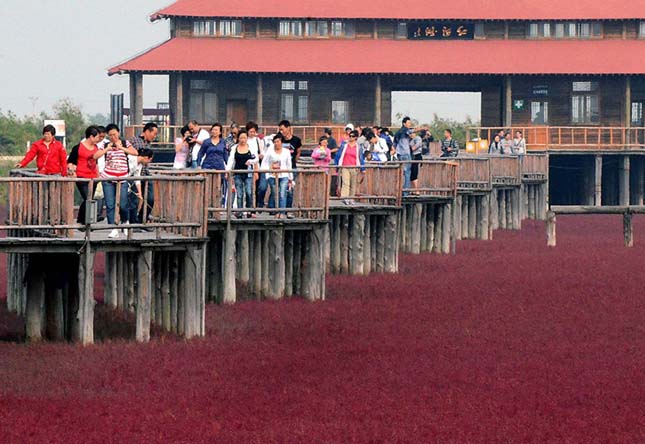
[{"left": 151, "top": 166, "right": 329, "bottom": 222}]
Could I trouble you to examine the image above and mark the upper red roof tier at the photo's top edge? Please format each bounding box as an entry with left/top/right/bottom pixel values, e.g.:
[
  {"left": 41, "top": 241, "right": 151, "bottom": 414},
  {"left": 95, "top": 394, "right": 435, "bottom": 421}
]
[{"left": 152, "top": 0, "right": 645, "bottom": 20}]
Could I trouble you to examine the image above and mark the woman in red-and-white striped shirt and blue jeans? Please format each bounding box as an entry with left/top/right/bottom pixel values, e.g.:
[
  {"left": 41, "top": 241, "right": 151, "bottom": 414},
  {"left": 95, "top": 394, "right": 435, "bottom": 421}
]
[{"left": 98, "top": 123, "right": 137, "bottom": 238}]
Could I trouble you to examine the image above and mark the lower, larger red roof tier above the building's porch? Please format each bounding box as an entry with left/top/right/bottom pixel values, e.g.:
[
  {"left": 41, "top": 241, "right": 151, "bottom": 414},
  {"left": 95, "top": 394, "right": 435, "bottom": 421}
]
[{"left": 108, "top": 38, "right": 645, "bottom": 75}]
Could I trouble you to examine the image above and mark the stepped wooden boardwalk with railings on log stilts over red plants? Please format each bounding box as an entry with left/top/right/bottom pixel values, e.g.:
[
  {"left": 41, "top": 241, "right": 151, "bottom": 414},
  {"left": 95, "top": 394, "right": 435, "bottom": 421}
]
[{"left": 0, "top": 156, "right": 548, "bottom": 344}]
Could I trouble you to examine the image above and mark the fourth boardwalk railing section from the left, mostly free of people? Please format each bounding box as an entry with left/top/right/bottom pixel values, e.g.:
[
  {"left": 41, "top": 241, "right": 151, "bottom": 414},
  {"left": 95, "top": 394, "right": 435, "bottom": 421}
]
[{"left": 400, "top": 160, "right": 459, "bottom": 198}]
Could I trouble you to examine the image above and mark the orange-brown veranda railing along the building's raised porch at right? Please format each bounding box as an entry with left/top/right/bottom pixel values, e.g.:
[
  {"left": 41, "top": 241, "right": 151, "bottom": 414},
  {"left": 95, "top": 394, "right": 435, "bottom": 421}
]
[{"left": 466, "top": 126, "right": 645, "bottom": 151}]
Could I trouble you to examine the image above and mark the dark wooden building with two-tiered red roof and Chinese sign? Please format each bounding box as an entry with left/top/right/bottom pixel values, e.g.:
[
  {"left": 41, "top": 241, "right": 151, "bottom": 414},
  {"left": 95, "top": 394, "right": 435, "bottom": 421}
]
[{"left": 109, "top": 0, "right": 645, "bottom": 204}]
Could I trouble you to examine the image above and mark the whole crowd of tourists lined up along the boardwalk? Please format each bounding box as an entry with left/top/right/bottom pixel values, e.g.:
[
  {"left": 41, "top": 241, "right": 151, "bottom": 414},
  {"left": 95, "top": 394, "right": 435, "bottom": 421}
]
[{"left": 16, "top": 117, "right": 526, "bottom": 229}]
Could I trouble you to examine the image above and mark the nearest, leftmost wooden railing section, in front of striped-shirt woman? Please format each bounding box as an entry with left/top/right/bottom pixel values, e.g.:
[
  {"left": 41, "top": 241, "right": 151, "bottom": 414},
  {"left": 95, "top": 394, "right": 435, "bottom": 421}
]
[{"left": 0, "top": 170, "right": 207, "bottom": 238}]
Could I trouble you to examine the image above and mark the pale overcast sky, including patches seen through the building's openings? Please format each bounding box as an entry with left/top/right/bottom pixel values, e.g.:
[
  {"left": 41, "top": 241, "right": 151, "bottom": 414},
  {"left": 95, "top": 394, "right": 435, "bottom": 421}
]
[{"left": 0, "top": 0, "right": 479, "bottom": 122}]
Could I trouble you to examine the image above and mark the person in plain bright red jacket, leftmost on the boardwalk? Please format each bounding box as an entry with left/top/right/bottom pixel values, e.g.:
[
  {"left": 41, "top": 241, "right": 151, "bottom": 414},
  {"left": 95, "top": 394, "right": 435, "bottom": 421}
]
[{"left": 15, "top": 125, "right": 67, "bottom": 176}]
